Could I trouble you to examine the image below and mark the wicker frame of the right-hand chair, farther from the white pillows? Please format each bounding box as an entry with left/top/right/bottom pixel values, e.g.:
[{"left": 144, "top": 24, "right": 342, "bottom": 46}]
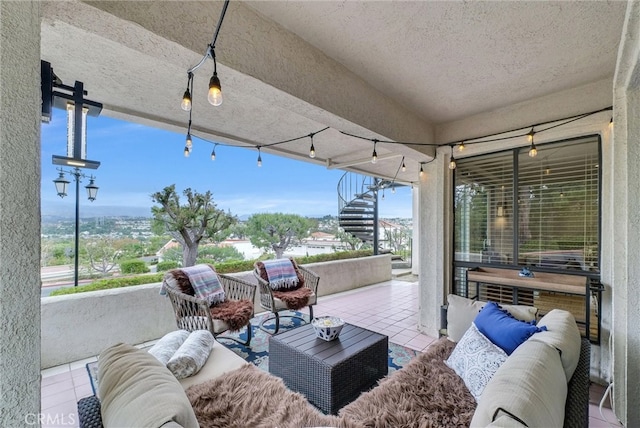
[{"left": 253, "top": 263, "right": 320, "bottom": 334}]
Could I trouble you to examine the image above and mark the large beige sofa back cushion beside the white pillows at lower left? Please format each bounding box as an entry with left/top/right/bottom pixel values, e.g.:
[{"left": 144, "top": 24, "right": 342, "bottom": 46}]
[{"left": 98, "top": 343, "right": 198, "bottom": 427}]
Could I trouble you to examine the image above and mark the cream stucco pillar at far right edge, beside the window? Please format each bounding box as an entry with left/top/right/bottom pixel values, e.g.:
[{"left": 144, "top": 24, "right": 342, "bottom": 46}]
[{"left": 610, "top": 1, "right": 640, "bottom": 427}]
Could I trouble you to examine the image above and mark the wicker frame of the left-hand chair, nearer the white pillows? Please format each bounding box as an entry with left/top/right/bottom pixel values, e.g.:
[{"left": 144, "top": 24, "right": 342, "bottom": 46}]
[{"left": 163, "top": 267, "right": 256, "bottom": 346}]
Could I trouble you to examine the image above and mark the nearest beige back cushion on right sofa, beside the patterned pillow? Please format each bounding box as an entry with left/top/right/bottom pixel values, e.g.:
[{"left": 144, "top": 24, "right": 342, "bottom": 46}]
[{"left": 471, "top": 340, "right": 567, "bottom": 427}]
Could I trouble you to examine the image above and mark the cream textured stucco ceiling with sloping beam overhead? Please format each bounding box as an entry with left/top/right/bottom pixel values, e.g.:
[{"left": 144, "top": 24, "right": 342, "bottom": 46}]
[{"left": 42, "top": 1, "right": 626, "bottom": 182}]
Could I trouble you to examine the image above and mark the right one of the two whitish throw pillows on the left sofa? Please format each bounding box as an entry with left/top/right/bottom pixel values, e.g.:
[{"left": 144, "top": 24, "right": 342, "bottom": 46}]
[{"left": 167, "top": 330, "right": 216, "bottom": 379}]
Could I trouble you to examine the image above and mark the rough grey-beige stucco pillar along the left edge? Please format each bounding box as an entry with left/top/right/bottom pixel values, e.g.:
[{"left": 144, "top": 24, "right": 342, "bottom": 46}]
[{"left": 0, "top": 1, "right": 40, "bottom": 427}]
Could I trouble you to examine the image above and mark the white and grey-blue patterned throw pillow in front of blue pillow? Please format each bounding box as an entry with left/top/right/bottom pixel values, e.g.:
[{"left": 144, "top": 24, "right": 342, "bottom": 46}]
[{"left": 445, "top": 324, "right": 507, "bottom": 401}]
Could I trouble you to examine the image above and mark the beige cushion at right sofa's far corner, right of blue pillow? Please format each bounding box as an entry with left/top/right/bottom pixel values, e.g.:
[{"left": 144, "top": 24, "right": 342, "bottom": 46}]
[{"left": 529, "top": 309, "right": 581, "bottom": 382}]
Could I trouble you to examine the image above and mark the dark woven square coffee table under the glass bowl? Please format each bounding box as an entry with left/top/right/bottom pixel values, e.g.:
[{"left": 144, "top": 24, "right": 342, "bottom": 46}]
[{"left": 269, "top": 324, "right": 389, "bottom": 414}]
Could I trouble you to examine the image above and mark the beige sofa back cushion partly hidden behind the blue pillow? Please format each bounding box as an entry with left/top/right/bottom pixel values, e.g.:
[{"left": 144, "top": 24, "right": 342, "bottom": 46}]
[{"left": 447, "top": 294, "right": 538, "bottom": 342}]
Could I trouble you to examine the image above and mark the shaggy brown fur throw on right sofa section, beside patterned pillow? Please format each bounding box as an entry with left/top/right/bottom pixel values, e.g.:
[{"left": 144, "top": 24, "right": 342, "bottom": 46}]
[{"left": 339, "top": 338, "right": 476, "bottom": 428}]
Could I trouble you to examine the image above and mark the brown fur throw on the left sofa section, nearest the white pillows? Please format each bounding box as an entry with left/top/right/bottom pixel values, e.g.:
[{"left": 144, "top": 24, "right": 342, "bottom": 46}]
[{"left": 186, "top": 364, "right": 344, "bottom": 428}]
